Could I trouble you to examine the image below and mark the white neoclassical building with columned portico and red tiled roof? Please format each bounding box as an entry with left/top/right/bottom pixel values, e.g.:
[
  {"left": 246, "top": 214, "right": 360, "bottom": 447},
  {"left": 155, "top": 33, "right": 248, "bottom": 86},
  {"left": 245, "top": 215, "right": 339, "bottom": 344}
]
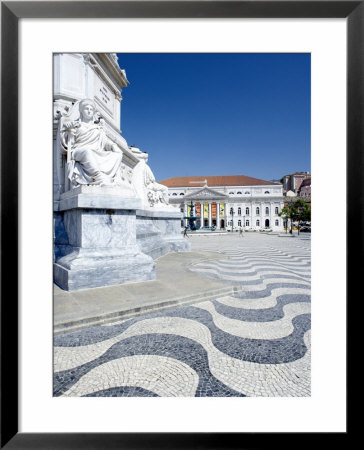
[{"left": 160, "top": 175, "right": 283, "bottom": 231}]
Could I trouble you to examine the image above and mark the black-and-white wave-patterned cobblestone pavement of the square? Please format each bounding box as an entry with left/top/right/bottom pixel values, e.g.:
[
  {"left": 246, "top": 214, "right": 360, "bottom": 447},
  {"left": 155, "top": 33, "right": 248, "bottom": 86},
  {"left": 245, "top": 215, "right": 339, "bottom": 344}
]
[{"left": 54, "top": 233, "right": 311, "bottom": 397}]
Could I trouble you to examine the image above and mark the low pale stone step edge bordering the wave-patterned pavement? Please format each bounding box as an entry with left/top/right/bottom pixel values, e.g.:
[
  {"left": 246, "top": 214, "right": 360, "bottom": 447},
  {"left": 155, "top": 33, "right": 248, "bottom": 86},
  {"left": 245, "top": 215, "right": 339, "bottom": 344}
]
[{"left": 53, "top": 286, "right": 242, "bottom": 334}]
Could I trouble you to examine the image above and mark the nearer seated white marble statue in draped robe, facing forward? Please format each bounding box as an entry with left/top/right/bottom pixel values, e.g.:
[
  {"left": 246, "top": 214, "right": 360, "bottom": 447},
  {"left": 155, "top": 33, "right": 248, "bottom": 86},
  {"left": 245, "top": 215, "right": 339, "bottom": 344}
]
[{"left": 60, "top": 99, "right": 123, "bottom": 186}]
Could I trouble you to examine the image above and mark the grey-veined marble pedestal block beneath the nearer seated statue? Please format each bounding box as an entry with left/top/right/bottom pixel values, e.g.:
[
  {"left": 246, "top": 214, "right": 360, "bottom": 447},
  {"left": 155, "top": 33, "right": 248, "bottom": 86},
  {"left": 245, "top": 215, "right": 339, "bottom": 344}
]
[{"left": 54, "top": 186, "right": 156, "bottom": 291}]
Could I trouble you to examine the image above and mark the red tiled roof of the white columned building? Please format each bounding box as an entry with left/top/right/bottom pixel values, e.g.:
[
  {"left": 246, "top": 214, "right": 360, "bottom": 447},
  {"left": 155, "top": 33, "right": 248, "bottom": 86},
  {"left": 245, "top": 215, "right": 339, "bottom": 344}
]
[{"left": 158, "top": 175, "right": 281, "bottom": 187}]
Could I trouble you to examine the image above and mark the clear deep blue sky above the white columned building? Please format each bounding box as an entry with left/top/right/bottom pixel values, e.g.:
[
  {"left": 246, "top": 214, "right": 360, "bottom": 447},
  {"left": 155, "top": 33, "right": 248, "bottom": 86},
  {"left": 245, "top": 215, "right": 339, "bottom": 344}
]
[{"left": 118, "top": 53, "right": 311, "bottom": 180}]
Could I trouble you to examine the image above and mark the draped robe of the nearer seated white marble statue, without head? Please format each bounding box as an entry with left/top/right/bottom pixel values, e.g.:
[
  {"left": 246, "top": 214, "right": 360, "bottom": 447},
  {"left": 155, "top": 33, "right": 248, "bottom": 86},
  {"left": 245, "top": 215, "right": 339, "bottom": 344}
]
[{"left": 68, "top": 122, "right": 122, "bottom": 184}]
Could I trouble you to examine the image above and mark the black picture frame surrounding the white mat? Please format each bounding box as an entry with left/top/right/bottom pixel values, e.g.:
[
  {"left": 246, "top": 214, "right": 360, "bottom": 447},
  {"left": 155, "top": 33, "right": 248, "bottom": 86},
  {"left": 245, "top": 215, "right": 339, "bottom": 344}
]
[{"left": 1, "top": 0, "right": 352, "bottom": 449}]
